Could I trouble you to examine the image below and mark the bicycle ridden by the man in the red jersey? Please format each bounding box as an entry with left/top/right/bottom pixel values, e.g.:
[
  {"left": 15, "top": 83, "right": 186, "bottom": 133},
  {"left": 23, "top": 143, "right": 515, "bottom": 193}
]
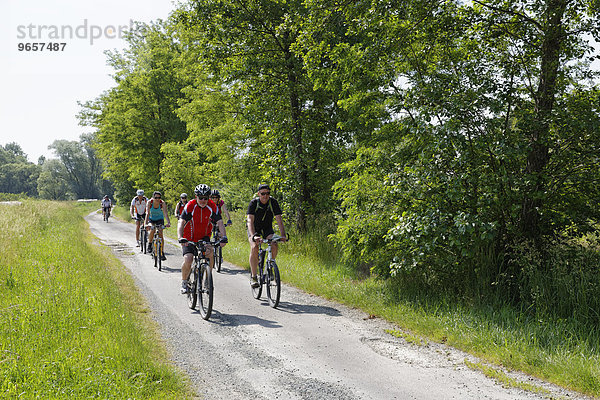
[{"left": 179, "top": 239, "right": 220, "bottom": 320}]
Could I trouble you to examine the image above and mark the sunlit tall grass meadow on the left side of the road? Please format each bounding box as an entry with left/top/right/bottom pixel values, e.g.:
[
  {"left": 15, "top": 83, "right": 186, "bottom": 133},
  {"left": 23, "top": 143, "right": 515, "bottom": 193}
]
[{"left": 0, "top": 200, "right": 191, "bottom": 399}]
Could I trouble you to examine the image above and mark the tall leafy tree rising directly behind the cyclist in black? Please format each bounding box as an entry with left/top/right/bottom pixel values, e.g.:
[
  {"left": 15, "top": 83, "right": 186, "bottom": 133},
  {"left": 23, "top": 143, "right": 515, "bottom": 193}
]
[{"left": 174, "top": 0, "right": 344, "bottom": 230}]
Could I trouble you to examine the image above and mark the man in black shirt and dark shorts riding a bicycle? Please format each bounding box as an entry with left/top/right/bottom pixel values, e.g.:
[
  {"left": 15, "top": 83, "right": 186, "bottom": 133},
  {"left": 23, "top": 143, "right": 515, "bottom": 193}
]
[{"left": 246, "top": 183, "right": 286, "bottom": 288}]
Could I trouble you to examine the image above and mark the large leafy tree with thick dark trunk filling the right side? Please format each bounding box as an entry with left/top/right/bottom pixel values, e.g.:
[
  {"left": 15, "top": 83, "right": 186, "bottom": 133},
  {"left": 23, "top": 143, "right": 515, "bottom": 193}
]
[{"left": 299, "top": 0, "right": 600, "bottom": 293}]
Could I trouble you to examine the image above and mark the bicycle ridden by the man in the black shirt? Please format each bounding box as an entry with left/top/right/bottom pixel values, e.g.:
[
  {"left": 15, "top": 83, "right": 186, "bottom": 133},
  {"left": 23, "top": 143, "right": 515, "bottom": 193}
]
[{"left": 252, "top": 235, "right": 283, "bottom": 308}]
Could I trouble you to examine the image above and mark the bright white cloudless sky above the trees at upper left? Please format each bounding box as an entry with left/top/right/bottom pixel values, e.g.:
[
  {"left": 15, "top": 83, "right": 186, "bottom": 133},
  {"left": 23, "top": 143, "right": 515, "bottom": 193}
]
[{"left": 0, "top": 0, "right": 175, "bottom": 162}]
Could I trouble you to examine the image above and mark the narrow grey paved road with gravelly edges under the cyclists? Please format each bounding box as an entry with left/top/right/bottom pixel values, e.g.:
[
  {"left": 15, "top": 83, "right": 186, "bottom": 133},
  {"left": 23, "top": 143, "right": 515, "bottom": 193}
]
[{"left": 87, "top": 213, "right": 577, "bottom": 400}]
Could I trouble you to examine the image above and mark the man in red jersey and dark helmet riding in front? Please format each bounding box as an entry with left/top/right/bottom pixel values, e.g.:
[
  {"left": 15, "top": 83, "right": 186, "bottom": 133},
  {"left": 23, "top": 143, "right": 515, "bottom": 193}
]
[{"left": 177, "top": 184, "right": 227, "bottom": 294}]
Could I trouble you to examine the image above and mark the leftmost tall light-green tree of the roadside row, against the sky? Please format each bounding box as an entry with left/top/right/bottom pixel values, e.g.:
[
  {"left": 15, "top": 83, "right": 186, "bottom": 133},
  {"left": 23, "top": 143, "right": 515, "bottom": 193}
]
[{"left": 79, "top": 21, "right": 187, "bottom": 205}]
